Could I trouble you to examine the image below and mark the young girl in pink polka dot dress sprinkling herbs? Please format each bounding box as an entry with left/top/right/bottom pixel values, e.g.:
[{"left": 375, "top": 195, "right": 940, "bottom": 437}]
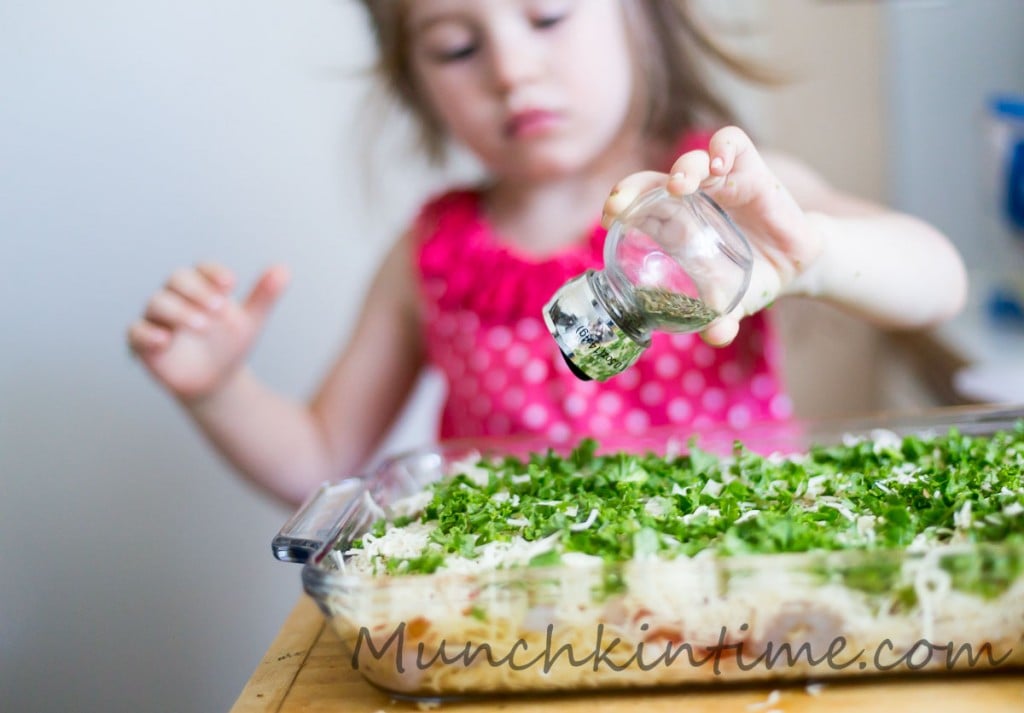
[{"left": 128, "top": 0, "right": 966, "bottom": 502}]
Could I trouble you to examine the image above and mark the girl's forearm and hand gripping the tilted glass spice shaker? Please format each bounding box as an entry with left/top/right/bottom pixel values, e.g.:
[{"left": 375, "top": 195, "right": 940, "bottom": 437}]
[{"left": 604, "top": 127, "right": 967, "bottom": 344}]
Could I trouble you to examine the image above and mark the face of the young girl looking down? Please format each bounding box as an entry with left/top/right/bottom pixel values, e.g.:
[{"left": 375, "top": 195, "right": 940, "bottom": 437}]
[{"left": 408, "top": 0, "right": 633, "bottom": 180}]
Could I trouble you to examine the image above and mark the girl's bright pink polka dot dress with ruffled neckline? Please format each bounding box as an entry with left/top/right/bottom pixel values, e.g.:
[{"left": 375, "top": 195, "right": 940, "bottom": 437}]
[{"left": 415, "top": 146, "right": 792, "bottom": 443}]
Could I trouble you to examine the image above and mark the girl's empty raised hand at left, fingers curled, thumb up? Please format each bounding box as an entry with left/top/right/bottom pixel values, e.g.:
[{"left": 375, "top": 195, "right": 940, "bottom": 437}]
[{"left": 128, "top": 264, "right": 289, "bottom": 403}]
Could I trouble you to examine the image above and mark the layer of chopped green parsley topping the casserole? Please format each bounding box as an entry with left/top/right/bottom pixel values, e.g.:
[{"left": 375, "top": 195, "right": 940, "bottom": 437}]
[{"left": 351, "top": 421, "right": 1024, "bottom": 593}]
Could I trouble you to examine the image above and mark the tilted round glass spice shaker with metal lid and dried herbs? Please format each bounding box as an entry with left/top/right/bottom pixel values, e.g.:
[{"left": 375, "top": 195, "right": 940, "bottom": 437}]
[{"left": 544, "top": 188, "right": 754, "bottom": 381}]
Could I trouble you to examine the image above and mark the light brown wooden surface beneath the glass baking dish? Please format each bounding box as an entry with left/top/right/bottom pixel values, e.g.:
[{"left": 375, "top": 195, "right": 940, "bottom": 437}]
[{"left": 231, "top": 596, "right": 1024, "bottom": 713}]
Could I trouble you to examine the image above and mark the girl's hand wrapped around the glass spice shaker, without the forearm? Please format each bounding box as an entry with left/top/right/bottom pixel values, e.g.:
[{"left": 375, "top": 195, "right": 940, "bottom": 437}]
[{"left": 602, "top": 127, "right": 821, "bottom": 345}]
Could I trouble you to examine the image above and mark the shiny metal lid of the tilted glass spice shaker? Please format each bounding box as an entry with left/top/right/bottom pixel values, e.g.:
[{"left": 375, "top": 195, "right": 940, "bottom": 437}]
[{"left": 544, "top": 270, "right": 647, "bottom": 381}]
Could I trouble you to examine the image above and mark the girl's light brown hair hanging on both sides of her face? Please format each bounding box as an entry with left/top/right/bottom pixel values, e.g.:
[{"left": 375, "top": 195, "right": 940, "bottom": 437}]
[{"left": 360, "top": 0, "right": 774, "bottom": 163}]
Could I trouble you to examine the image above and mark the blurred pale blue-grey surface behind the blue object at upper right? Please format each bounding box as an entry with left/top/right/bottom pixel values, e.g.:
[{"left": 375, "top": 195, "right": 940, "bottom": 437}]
[{"left": 884, "top": 0, "right": 1024, "bottom": 272}]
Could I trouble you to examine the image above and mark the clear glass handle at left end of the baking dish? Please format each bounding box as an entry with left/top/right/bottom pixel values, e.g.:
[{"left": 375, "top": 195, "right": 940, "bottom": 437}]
[{"left": 271, "top": 477, "right": 367, "bottom": 564}]
